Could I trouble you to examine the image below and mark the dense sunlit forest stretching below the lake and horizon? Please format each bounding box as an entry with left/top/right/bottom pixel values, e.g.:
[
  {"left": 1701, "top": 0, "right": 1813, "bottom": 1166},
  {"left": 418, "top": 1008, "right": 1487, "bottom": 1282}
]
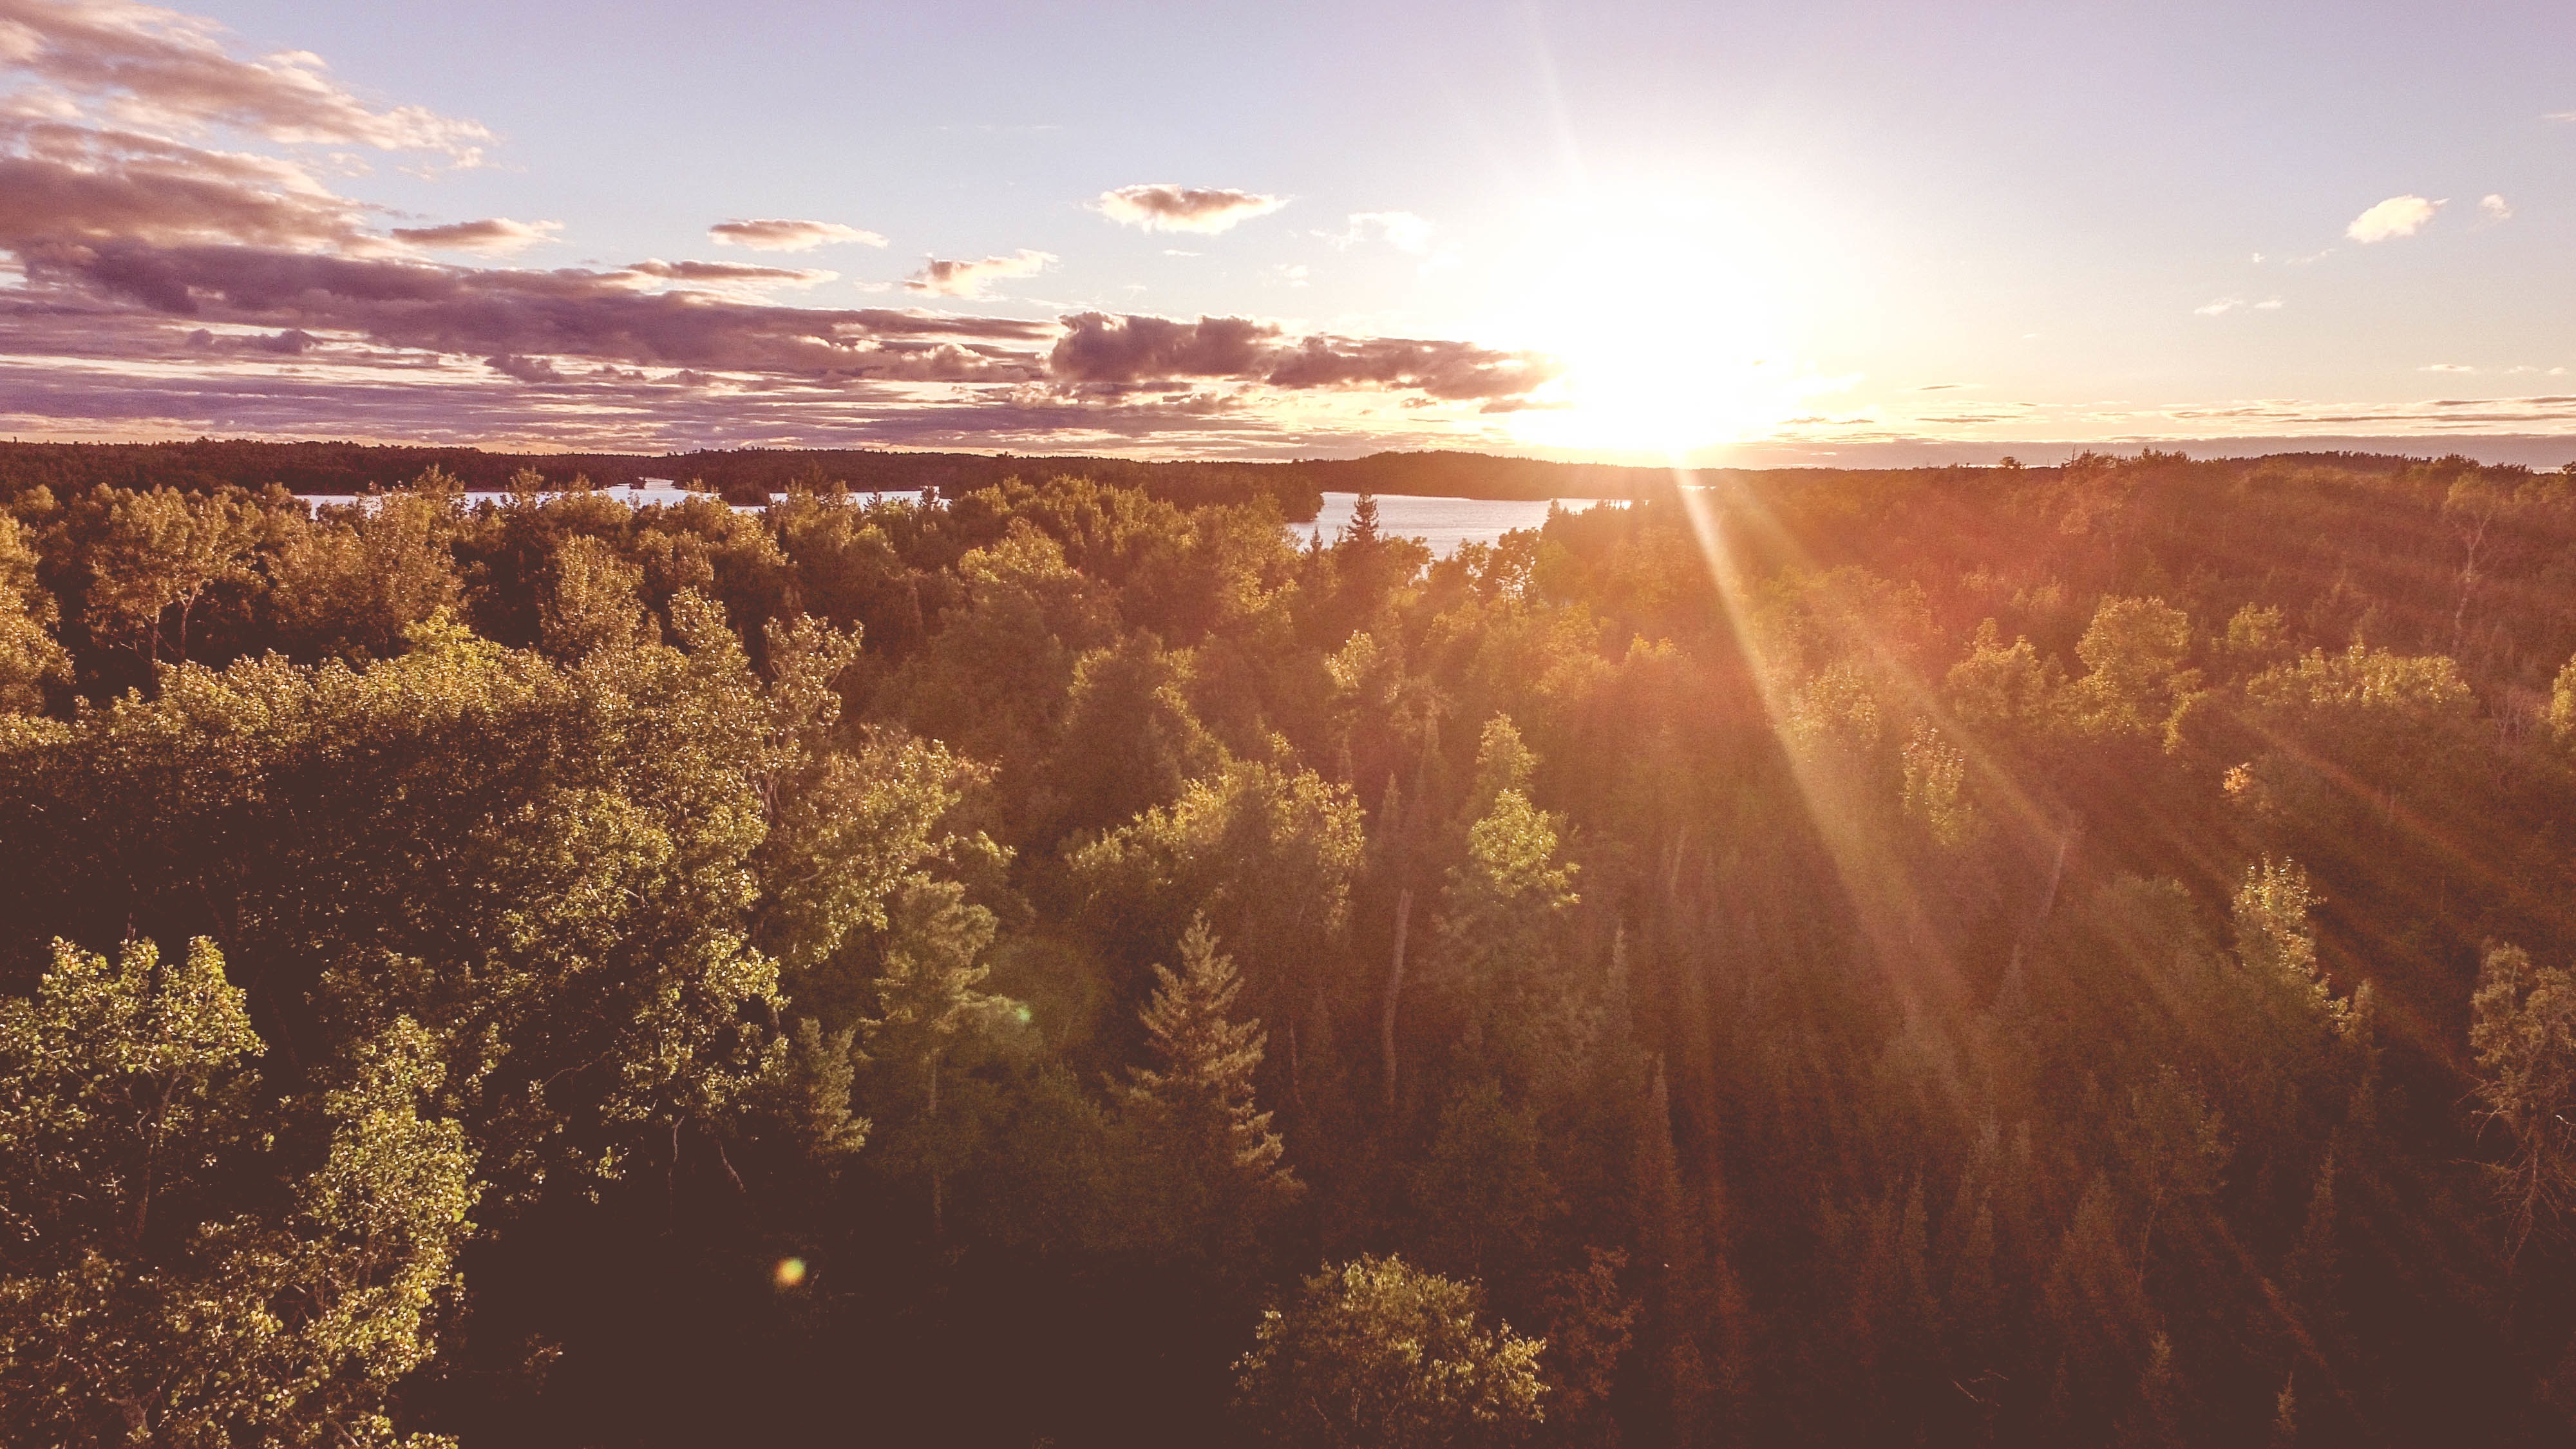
[{"left": 0, "top": 449, "right": 2576, "bottom": 1449}]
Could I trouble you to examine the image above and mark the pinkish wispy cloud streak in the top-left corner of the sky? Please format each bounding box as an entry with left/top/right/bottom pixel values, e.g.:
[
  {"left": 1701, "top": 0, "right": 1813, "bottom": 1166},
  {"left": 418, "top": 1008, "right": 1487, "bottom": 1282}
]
[{"left": 0, "top": 0, "right": 492, "bottom": 165}]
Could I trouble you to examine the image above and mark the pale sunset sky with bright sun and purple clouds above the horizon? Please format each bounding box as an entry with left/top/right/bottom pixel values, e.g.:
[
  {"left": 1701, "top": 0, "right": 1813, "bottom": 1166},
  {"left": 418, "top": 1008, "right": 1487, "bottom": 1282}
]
[{"left": 0, "top": 0, "right": 2576, "bottom": 467}]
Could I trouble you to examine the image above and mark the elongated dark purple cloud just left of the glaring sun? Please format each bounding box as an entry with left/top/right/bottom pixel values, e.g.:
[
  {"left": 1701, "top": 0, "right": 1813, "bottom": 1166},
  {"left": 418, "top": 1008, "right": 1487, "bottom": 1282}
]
[{"left": 1046, "top": 312, "right": 1561, "bottom": 400}]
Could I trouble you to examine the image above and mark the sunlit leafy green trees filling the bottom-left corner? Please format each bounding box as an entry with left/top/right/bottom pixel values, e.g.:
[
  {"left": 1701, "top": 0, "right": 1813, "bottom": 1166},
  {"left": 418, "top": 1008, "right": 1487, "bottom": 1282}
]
[{"left": 0, "top": 941, "right": 479, "bottom": 1446}]
